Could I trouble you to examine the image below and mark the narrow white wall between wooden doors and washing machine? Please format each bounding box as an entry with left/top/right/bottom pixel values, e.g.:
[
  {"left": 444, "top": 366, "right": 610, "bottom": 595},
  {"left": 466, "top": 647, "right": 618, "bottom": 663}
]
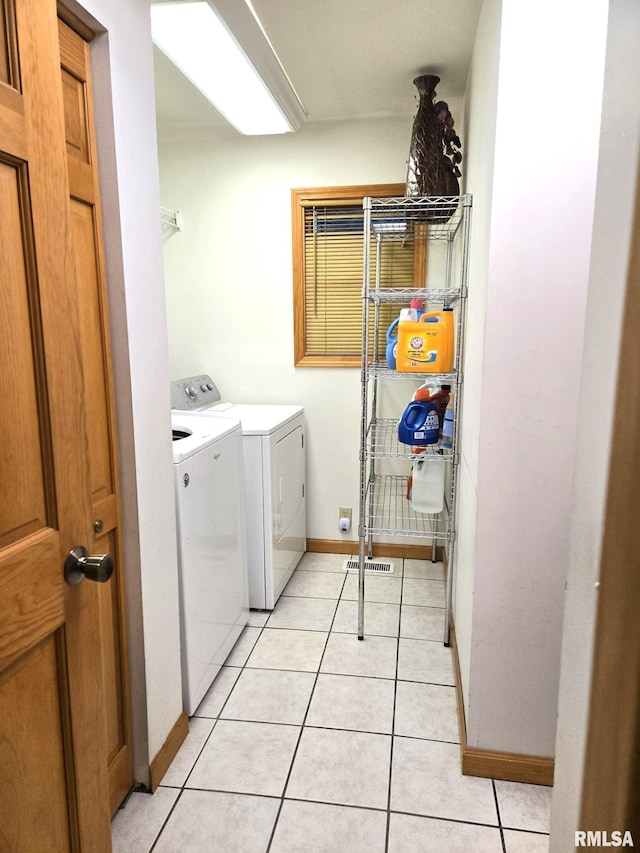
[{"left": 68, "top": 0, "right": 182, "bottom": 782}]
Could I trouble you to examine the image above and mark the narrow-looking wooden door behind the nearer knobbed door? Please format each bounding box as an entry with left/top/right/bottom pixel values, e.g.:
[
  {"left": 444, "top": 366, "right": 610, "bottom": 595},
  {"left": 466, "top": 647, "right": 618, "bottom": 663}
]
[{"left": 58, "top": 16, "right": 133, "bottom": 814}]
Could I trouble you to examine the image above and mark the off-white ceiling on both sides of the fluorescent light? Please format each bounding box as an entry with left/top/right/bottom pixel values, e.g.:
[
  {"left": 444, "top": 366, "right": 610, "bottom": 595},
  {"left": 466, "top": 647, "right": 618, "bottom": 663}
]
[{"left": 154, "top": 0, "right": 482, "bottom": 135}]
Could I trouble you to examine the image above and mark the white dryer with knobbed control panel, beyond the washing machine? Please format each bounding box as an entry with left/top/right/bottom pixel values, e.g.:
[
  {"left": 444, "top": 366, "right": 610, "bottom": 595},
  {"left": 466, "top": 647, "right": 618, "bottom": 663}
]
[{"left": 171, "top": 374, "right": 307, "bottom": 610}]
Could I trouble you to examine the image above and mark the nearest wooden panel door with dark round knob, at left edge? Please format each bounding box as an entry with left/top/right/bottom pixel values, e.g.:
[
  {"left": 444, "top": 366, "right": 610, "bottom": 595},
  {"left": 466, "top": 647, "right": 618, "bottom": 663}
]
[{"left": 0, "top": 0, "right": 129, "bottom": 853}]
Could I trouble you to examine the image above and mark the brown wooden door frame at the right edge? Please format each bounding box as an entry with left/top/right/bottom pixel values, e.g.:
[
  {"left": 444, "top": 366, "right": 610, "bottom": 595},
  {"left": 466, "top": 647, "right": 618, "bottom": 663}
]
[{"left": 579, "top": 165, "right": 640, "bottom": 832}]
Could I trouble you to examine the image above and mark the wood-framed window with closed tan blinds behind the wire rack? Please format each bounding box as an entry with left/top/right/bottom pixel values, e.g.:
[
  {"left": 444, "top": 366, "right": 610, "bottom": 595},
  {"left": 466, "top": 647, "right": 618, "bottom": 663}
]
[{"left": 292, "top": 184, "right": 414, "bottom": 367}]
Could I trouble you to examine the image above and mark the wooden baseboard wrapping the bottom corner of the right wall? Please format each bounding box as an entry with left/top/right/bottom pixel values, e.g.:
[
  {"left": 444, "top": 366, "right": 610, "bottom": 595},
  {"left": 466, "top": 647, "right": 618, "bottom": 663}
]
[{"left": 451, "top": 625, "right": 555, "bottom": 786}]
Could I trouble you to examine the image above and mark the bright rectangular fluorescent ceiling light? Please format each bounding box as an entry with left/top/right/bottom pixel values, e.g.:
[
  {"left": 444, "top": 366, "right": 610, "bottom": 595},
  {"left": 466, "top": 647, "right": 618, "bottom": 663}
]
[{"left": 151, "top": 0, "right": 304, "bottom": 135}]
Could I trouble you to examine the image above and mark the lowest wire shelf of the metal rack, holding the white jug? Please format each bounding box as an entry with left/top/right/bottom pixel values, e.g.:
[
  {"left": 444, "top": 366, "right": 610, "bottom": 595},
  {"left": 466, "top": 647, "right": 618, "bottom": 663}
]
[{"left": 365, "top": 474, "right": 453, "bottom": 540}]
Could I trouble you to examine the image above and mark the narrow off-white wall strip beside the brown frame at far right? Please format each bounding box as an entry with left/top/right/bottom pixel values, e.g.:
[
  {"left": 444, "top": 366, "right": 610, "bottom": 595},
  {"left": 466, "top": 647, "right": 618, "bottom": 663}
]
[{"left": 550, "top": 0, "right": 640, "bottom": 853}]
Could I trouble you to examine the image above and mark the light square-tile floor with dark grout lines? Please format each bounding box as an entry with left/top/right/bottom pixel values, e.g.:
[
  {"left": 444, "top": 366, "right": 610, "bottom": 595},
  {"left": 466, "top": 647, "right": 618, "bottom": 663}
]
[{"left": 113, "top": 554, "right": 551, "bottom": 853}]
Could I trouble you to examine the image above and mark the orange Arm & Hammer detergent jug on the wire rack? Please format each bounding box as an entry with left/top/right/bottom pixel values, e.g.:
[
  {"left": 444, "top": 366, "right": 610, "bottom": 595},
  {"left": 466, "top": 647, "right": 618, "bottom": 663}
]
[{"left": 396, "top": 308, "right": 454, "bottom": 373}]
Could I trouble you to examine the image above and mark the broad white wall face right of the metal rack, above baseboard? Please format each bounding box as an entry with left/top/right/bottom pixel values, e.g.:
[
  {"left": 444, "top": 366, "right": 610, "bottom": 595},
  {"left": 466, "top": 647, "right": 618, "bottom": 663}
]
[{"left": 456, "top": 0, "right": 607, "bottom": 756}]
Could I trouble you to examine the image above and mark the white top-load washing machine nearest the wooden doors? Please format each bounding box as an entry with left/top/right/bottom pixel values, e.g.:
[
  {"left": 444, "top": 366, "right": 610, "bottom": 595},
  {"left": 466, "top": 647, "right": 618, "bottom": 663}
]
[{"left": 171, "top": 412, "right": 249, "bottom": 715}]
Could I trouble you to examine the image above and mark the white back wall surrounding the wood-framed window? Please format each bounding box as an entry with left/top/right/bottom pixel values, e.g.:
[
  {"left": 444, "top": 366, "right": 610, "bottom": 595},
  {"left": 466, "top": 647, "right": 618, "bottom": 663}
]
[{"left": 160, "top": 115, "right": 430, "bottom": 540}]
